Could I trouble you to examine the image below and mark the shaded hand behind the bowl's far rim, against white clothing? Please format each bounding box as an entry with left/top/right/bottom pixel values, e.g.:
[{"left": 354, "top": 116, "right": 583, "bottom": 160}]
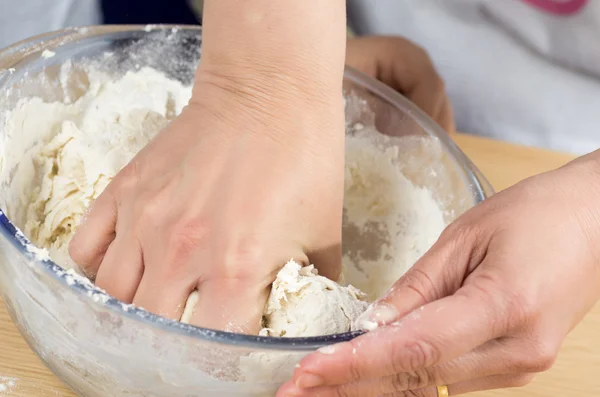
[{"left": 346, "top": 36, "right": 454, "bottom": 133}]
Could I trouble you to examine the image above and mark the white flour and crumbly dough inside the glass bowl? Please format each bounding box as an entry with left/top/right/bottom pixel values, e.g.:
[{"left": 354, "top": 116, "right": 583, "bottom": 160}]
[{"left": 0, "top": 65, "right": 445, "bottom": 336}]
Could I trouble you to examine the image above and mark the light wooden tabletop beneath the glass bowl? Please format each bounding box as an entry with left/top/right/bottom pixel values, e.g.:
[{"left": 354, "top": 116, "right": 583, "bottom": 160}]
[{"left": 0, "top": 135, "right": 600, "bottom": 397}]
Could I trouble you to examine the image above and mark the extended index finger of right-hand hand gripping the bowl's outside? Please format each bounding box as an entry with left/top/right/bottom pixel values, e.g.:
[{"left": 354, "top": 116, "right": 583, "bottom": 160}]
[{"left": 294, "top": 264, "right": 509, "bottom": 387}]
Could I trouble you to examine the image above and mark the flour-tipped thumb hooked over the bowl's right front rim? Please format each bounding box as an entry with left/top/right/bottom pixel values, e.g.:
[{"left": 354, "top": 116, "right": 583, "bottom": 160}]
[{"left": 355, "top": 223, "right": 485, "bottom": 331}]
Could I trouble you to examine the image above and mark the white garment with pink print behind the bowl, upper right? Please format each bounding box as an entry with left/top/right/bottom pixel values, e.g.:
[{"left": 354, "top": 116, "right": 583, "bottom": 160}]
[{"left": 348, "top": 0, "right": 600, "bottom": 154}]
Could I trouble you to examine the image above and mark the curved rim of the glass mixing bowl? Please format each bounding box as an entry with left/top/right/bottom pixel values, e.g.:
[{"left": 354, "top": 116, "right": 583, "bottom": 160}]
[{"left": 0, "top": 24, "right": 493, "bottom": 352}]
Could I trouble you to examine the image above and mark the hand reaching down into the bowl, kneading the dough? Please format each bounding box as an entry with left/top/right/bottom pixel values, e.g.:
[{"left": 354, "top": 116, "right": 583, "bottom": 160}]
[{"left": 70, "top": 67, "right": 344, "bottom": 333}]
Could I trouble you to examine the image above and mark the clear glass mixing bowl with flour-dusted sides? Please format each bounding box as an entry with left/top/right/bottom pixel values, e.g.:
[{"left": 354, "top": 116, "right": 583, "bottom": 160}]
[{"left": 0, "top": 26, "right": 493, "bottom": 397}]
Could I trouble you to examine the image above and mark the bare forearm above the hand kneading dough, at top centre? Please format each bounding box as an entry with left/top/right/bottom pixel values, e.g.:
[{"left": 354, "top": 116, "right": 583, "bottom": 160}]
[{"left": 199, "top": 0, "right": 346, "bottom": 94}]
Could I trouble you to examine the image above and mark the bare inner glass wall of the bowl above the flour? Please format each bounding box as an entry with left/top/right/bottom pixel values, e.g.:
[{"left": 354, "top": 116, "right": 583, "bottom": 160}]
[{"left": 0, "top": 26, "right": 484, "bottom": 344}]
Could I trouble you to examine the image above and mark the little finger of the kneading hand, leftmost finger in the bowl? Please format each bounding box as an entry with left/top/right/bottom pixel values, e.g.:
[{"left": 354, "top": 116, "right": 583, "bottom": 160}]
[{"left": 69, "top": 189, "right": 117, "bottom": 277}]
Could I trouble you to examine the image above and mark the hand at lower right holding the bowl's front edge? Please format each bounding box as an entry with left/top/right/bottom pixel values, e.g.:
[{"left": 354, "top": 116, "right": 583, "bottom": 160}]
[{"left": 278, "top": 152, "right": 600, "bottom": 397}]
